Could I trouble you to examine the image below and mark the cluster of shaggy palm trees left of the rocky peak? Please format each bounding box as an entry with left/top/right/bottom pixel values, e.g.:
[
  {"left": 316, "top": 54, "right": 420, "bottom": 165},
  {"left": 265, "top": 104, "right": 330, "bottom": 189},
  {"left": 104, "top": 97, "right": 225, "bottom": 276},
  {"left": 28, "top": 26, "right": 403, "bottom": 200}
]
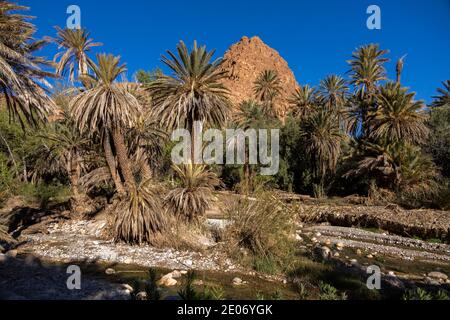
[{"left": 0, "top": 1, "right": 230, "bottom": 243}]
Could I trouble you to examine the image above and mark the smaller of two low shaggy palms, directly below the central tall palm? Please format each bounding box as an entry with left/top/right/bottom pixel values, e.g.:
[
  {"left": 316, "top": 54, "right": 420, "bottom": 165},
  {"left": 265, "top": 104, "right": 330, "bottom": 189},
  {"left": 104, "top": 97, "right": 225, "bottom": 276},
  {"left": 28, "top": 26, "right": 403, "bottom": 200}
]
[{"left": 164, "top": 164, "right": 220, "bottom": 221}]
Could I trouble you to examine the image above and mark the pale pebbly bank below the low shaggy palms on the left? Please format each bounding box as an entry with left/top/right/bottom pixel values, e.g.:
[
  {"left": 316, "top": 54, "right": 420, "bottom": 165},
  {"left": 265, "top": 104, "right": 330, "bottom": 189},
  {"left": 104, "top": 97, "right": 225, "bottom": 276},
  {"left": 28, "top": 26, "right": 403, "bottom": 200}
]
[{"left": 13, "top": 220, "right": 236, "bottom": 272}]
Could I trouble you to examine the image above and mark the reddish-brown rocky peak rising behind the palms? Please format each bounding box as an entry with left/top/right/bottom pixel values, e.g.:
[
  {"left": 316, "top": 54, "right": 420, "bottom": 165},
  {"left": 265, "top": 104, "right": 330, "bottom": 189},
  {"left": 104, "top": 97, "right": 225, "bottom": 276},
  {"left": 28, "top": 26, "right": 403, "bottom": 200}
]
[{"left": 222, "top": 36, "right": 298, "bottom": 114}]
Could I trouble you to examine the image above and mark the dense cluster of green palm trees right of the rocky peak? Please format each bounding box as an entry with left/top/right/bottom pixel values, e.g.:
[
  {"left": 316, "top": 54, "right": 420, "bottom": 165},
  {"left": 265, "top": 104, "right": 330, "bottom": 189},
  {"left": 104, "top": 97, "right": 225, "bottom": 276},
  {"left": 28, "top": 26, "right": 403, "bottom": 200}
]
[{"left": 282, "top": 44, "right": 445, "bottom": 200}]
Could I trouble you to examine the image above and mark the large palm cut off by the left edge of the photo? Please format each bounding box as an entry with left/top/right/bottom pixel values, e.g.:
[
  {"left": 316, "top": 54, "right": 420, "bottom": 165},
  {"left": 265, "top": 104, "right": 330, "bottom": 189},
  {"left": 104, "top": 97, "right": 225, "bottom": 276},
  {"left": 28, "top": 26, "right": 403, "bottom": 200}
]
[{"left": 0, "top": 1, "right": 54, "bottom": 127}]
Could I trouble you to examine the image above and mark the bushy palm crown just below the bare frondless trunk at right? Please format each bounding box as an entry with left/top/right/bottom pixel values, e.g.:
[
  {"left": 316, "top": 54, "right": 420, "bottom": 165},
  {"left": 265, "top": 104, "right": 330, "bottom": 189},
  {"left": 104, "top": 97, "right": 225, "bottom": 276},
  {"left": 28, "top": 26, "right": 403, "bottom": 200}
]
[{"left": 369, "top": 82, "right": 428, "bottom": 143}]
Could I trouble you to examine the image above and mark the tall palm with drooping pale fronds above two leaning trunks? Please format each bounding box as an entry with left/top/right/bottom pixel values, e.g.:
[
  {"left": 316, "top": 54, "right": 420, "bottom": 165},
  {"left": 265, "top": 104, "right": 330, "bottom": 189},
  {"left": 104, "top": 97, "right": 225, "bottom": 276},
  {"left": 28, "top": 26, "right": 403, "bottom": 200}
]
[{"left": 70, "top": 54, "right": 141, "bottom": 193}]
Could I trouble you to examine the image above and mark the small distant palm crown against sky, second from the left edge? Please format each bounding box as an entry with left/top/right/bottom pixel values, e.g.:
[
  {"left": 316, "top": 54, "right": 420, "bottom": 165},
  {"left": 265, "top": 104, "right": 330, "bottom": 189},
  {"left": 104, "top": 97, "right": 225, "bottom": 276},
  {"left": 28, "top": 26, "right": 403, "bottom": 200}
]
[{"left": 49, "top": 27, "right": 102, "bottom": 82}]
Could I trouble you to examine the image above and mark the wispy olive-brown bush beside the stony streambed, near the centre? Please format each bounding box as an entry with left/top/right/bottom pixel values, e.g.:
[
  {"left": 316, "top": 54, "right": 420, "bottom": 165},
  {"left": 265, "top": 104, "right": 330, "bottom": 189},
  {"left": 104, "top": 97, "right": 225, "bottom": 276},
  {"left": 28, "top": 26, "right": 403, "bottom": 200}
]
[{"left": 224, "top": 192, "right": 295, "bottom": 273}]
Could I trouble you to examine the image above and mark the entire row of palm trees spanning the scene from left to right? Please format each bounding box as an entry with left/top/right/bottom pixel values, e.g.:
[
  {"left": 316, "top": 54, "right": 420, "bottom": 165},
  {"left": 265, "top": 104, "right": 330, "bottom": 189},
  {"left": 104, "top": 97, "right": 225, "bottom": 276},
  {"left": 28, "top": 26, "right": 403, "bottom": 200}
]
[{"left": 0, "top": 1, "right": 450, "bottom": 243}]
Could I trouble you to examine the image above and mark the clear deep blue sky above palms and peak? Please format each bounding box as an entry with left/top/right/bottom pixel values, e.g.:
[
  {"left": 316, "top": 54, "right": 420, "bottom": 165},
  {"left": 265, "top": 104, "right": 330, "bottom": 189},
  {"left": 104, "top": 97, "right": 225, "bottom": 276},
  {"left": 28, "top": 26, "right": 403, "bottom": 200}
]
[{"left": 22, "top": 0, "right": 450, "bottom": 101}]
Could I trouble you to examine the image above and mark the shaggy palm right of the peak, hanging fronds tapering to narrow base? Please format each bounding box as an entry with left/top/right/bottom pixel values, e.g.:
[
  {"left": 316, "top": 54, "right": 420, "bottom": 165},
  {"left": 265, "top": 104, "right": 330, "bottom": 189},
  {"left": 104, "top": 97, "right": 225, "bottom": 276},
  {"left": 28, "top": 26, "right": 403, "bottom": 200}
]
[{"left": 302, "top": 109, "right": 344, "bottom": 195}]
